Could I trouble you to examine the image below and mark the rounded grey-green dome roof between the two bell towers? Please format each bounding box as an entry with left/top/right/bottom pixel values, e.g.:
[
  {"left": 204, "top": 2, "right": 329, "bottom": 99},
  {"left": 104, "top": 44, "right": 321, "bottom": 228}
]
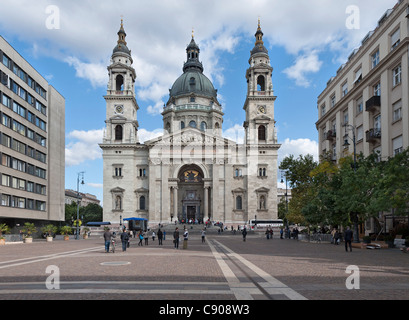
[{"left": 170, "top": 71, "right": 217, "bottom": 98}]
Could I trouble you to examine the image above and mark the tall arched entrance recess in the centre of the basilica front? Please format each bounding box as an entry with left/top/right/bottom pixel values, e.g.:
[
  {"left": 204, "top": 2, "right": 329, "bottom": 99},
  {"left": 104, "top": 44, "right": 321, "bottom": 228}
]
[{"left": 177, "top": 164, "right": 204, "bottom": 222}]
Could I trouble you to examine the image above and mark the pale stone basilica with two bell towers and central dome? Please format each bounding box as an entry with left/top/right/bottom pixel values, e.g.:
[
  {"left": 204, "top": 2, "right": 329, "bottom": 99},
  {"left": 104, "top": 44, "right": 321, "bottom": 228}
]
[{"left": 100, "top": 22, "right": 280, "bottom": 224}]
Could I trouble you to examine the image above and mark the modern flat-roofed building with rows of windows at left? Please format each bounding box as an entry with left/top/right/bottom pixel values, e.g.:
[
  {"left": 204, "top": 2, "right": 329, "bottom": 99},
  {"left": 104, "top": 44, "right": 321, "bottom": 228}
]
[{"left": 0, "top": 36, "right": 65, "bottom": 227}]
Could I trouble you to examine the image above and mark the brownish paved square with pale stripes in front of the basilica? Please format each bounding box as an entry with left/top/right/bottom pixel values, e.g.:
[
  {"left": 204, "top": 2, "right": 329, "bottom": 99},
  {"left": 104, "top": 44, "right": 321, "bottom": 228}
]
[{"left": 0, "top": 233, "right": 409, "bottom": 301}]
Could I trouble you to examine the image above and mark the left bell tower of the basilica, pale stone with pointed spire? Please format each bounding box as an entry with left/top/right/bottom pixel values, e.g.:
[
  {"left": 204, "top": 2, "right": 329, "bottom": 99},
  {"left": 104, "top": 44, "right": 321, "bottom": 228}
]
[{"left": 104, "top": 20, "right": 139, "bottom": 144}]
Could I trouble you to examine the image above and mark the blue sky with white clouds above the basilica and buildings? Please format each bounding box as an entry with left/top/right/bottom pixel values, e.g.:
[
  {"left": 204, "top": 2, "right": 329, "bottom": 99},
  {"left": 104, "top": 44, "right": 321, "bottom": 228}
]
[{"left": 0, "top": 0, "right": 397, "bottom": 205}]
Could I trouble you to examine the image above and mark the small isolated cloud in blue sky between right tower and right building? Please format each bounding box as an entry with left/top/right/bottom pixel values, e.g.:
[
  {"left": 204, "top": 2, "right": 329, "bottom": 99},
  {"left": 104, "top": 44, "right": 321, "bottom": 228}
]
[{"left": 283, "top": 51, "right": 322, "bottom": 88}]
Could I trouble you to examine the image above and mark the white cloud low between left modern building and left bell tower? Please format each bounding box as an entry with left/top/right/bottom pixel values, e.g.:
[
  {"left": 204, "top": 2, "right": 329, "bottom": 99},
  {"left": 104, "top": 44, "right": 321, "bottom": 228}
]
[{"left": 65, "top": 129, "right": 104, "bottom": 167}]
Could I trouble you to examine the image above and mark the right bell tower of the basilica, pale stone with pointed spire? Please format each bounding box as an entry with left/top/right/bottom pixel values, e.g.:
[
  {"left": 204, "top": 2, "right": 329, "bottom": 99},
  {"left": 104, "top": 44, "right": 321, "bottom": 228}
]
[{"left": 243, "top": 20, "right": 277, "bottom": 145}]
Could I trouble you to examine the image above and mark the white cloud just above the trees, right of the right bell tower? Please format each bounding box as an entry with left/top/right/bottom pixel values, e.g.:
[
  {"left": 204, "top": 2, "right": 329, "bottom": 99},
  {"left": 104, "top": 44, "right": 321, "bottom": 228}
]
[{"left": 278, "top": 138, "right": 319, "bottom": 163}]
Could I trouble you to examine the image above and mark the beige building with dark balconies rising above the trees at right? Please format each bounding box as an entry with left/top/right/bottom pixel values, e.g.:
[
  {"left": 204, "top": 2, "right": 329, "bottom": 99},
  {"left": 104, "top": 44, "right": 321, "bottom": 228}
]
[{"left": 316, "top": 0, "right": 409, "bottom": 230}]
